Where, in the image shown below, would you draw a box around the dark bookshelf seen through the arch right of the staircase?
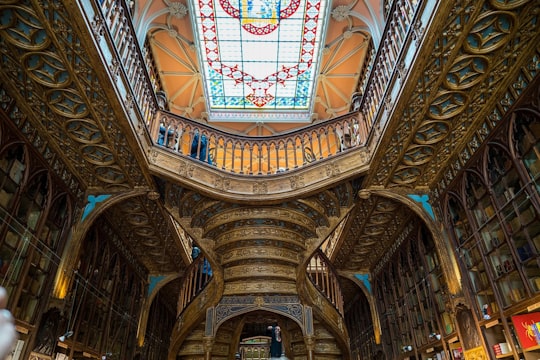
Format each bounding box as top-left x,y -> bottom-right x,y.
374,225 -> 450,359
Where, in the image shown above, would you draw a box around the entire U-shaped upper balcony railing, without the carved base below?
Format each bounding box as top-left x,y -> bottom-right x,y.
88,0 -> 433,175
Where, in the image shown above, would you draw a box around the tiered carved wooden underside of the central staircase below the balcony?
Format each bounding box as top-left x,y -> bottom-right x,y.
163,183 -> 358,295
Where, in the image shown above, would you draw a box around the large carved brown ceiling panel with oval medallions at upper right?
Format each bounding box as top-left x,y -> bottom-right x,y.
367,1 -> 539,189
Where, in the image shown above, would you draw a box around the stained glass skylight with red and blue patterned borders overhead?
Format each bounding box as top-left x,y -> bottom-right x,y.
192,0 -> 327,121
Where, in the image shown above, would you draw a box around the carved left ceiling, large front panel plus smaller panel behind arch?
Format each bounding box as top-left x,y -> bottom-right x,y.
0,2 -> 186,273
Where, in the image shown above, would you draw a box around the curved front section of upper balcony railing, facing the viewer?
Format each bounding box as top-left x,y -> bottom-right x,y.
152,111 -> 368,175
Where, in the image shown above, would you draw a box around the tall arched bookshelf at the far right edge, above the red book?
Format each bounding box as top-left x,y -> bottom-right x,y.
445,116 -> 540,359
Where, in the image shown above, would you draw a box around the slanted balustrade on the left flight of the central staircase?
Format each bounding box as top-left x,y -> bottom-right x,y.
177,255 -> 212,314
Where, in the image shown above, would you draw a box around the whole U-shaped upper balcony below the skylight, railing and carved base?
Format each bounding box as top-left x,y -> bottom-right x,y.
79,0 -> 435,200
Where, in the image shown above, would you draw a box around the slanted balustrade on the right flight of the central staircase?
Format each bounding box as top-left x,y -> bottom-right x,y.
307,250 -> 344,316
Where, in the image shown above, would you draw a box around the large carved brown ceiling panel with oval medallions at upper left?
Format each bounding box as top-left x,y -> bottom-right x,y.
0,1 -> 150,189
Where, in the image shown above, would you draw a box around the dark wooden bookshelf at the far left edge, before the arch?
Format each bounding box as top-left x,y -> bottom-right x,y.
0,144 -> 73,330
